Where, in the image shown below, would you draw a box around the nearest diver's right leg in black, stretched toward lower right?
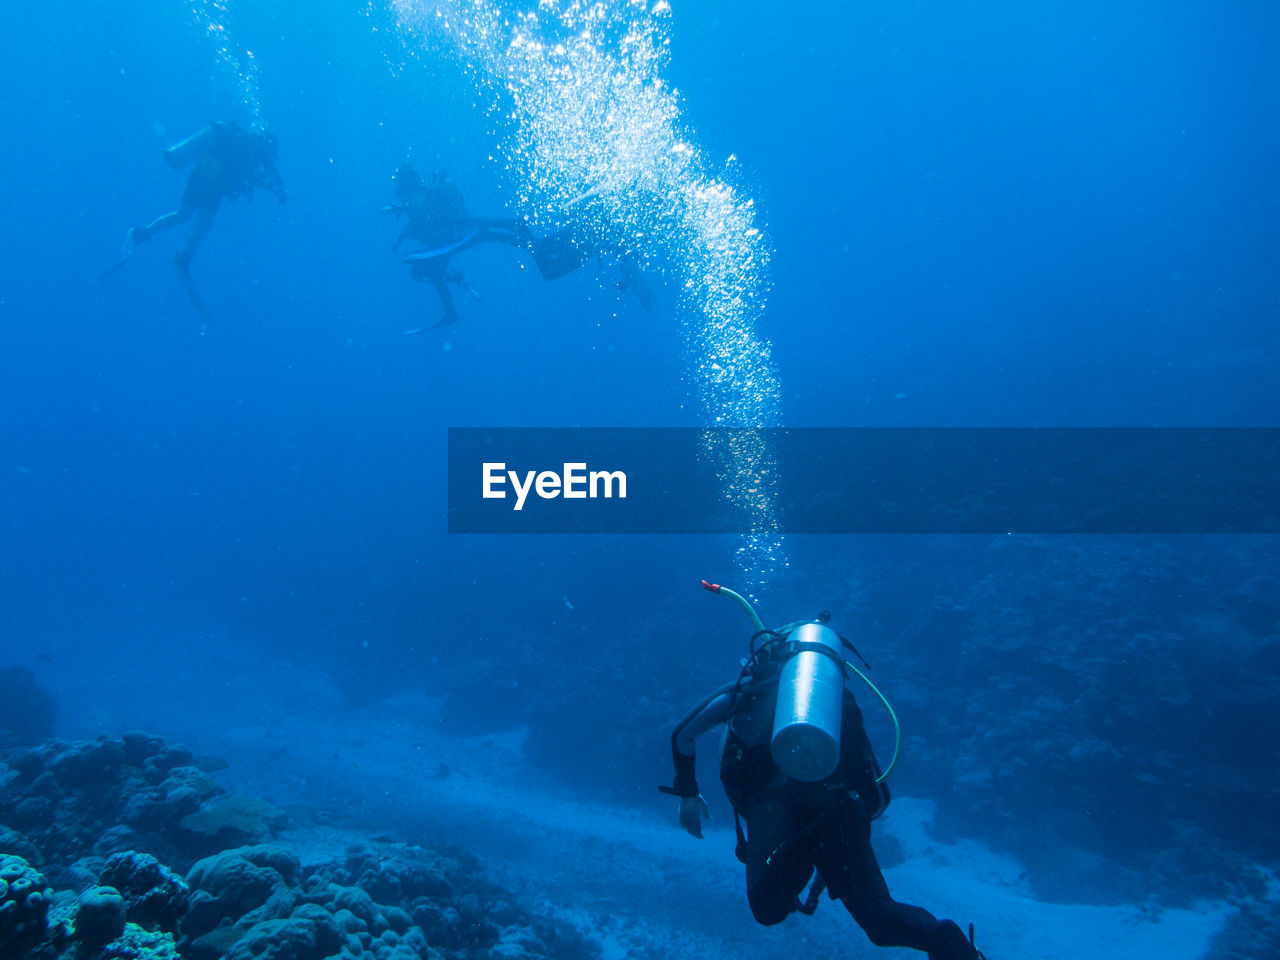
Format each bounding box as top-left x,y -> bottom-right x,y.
815,801 -> 978,960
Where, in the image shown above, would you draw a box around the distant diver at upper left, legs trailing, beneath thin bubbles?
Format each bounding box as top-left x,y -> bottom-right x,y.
99,120 -> 288,320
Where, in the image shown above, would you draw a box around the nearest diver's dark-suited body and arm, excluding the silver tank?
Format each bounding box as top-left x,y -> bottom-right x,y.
659,611 -> 983,960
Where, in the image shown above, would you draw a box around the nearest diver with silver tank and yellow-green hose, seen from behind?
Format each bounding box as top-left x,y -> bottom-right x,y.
659,580 -> 983,960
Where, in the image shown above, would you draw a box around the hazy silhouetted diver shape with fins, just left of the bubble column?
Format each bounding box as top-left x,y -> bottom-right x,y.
381,164 -> 616,334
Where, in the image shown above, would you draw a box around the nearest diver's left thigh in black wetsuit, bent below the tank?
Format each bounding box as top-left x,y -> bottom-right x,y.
745,794 -> 813,927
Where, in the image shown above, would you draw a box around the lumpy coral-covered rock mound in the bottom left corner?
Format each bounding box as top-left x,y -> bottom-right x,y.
0,733 -> 600,960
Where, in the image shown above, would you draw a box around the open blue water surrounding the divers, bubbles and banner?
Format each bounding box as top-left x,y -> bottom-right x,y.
0,0 -> 1280,957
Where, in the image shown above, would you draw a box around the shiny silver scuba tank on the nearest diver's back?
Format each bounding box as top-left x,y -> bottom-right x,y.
771,623 -> 845,782
